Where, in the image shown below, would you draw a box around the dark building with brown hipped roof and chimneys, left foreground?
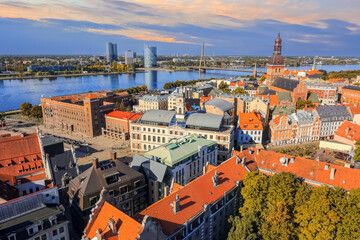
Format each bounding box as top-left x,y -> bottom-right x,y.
68,152 -> 147,229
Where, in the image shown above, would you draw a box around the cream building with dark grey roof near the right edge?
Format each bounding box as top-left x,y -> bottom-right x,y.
316,106 -> 352,139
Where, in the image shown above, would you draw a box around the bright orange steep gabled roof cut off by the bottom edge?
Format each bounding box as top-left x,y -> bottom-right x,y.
84,202 -> 143,240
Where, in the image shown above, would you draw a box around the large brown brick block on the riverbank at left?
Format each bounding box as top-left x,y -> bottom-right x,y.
41,91 -> 129,137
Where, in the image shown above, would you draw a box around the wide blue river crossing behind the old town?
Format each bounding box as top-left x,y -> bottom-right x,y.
0,65 -> 360,111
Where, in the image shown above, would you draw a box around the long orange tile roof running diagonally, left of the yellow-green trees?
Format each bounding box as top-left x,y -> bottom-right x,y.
134,152 -> 256,235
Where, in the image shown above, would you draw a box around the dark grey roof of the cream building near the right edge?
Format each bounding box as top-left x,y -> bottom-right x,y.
316,106 -> 352,122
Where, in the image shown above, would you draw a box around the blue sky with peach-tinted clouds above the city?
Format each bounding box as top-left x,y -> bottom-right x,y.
0,0 -> 360,56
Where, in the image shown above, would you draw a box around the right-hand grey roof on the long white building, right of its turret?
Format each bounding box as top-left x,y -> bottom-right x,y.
186,113 -> 223,130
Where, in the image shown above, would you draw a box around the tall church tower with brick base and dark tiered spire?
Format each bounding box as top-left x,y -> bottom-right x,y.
266,33 -> 285,88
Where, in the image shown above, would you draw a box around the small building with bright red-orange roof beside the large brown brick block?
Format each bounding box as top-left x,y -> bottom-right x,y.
102,110 -> 142,140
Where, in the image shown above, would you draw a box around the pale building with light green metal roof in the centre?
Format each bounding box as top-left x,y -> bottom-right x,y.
144,134 -> 218,186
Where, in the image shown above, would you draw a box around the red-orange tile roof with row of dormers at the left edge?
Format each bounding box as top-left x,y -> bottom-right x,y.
0,133 -> 44,180
